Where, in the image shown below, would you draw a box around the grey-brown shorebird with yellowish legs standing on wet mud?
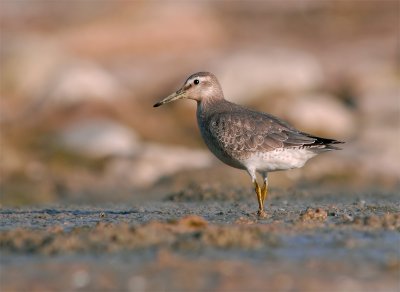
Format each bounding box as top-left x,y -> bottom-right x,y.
154,72 -> 343,218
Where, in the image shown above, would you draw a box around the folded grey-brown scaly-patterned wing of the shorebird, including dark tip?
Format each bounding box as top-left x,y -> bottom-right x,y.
210,111 -> 338,152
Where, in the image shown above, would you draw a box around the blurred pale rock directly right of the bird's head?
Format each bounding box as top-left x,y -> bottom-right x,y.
213,49 -> 323,103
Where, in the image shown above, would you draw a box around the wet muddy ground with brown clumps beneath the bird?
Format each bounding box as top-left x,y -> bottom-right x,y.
0,186 -> 400,291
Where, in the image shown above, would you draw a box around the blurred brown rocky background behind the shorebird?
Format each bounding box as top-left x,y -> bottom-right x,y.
0,0 -> 400,206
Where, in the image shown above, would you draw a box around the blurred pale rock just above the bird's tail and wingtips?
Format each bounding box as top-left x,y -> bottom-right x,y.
272,94 -> 357,139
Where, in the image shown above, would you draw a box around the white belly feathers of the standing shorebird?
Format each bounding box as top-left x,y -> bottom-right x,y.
243,148 -> 317,172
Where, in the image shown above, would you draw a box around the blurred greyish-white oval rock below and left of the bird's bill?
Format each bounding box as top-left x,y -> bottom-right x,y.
59,119 -> 139,158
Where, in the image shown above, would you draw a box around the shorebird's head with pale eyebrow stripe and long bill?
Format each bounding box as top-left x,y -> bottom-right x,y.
154,72 -> 224,107
